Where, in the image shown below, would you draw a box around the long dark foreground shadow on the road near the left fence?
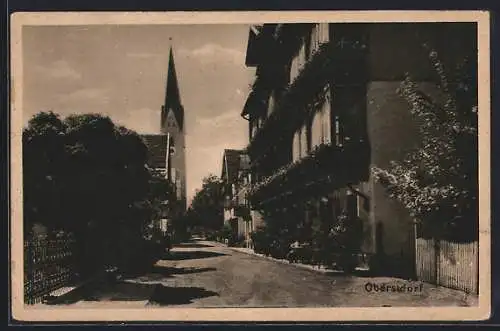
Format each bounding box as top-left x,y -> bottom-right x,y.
83,281 -> 218,306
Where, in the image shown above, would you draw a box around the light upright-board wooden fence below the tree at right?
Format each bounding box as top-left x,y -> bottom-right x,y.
416,238 -> 479,294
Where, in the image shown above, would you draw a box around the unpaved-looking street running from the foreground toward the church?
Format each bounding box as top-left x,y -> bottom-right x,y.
72,241 -> 474,307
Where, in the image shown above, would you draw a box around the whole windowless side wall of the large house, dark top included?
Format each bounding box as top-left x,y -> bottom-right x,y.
358,24 -> 466,276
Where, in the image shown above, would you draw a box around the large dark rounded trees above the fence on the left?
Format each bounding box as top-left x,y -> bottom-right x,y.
23,112 -> 172,274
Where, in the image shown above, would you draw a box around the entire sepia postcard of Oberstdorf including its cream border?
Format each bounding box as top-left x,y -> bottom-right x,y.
10,11 -> 491,321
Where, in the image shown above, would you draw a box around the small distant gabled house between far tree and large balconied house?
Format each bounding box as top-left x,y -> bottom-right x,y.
221,149 -> 251,245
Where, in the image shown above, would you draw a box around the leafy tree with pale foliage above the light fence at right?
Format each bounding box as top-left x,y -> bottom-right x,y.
373,46 -> 478,240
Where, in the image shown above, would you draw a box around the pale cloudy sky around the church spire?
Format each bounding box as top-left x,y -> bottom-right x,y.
23,25 -> 254,202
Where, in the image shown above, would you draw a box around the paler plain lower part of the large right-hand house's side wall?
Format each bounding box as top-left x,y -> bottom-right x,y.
359,81 -> 442,276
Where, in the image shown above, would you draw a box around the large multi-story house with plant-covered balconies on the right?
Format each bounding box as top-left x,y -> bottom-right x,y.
242,23 -> 476,276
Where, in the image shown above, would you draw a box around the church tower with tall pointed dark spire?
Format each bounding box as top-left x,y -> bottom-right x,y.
161,47 -> 186,213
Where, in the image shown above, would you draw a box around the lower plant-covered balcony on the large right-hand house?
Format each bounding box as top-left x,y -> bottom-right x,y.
249,142 -> 370,206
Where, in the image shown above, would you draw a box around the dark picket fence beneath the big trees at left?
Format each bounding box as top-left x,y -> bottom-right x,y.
24,238 -> 75,304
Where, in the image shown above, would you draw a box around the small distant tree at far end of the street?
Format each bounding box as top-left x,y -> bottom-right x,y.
187,174 -> 224,230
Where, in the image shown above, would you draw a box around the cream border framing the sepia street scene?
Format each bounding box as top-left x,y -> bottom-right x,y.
10,11 -> 491,322
